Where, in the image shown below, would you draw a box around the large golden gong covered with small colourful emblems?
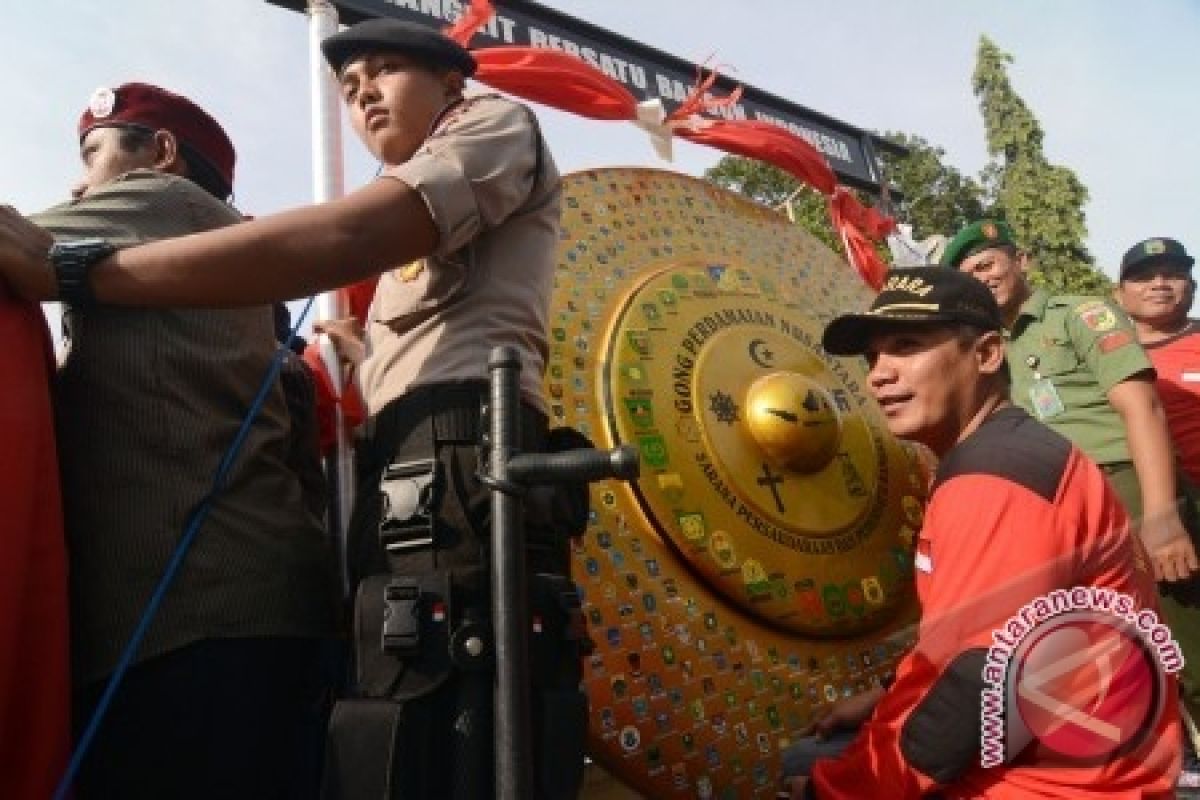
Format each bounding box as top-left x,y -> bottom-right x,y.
546,169 -> 925,798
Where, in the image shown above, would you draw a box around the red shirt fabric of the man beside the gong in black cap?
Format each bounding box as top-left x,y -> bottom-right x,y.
812,439 -> 1181,800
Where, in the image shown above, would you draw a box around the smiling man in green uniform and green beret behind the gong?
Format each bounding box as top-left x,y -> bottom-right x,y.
942,219 -> 1200,715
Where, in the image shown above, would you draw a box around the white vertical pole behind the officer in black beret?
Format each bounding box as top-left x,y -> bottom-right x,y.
308,0 -> 354,591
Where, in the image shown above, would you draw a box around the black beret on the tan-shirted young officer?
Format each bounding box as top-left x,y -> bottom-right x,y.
320,17 -> 476,78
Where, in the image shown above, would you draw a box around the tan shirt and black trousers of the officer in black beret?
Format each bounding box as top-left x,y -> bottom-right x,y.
332,95 -> 587,798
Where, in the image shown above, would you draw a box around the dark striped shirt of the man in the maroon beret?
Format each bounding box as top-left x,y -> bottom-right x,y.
34,170 -> 336,685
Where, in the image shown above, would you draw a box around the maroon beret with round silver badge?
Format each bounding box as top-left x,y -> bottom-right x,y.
79,83 -> 235,188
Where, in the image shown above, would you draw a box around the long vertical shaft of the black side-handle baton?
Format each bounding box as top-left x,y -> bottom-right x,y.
487,347 -> 533,800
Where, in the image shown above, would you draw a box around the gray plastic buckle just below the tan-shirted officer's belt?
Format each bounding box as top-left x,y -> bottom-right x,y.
379,458 -> 445,555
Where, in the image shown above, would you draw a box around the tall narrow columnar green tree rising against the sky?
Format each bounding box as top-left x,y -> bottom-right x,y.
971,36 -> 1109,293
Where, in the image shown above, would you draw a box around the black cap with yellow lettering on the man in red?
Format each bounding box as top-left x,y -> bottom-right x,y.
821,266 -> 1004,355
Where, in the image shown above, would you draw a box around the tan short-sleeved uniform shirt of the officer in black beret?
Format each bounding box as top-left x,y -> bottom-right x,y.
360,95 -> 560,414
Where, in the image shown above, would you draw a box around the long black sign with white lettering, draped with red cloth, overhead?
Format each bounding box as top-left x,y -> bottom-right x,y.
268,0 -> 904,194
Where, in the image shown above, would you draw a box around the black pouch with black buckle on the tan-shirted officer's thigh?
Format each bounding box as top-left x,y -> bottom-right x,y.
354,571 -> 455,700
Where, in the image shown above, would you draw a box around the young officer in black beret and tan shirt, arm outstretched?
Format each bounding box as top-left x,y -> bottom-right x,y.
0,19 -> 586,798
